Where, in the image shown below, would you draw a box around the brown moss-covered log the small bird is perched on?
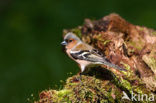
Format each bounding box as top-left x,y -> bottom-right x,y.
35,14 -> 156,103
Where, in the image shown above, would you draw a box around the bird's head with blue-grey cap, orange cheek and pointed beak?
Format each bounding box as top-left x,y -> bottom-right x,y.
61,32 -> 81,49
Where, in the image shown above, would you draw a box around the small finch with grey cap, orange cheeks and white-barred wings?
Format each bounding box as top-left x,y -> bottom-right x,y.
61,32 -> 126,73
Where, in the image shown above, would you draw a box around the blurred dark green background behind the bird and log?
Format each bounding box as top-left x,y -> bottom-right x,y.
0,0 -> 156,103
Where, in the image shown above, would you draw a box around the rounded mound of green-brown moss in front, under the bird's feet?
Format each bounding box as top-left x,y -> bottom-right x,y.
36,75 -> 127,103
